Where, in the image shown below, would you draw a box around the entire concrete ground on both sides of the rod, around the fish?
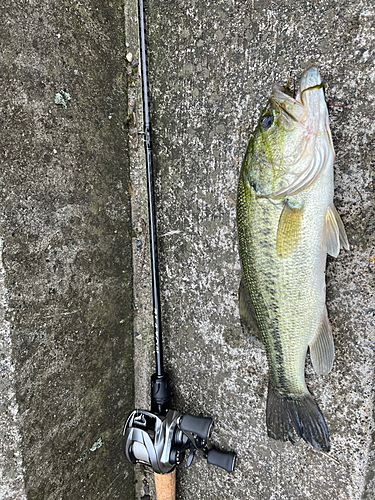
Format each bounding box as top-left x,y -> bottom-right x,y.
0,0 -> 375,500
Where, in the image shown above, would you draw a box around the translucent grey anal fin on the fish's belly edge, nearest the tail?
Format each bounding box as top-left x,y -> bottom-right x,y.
309,308 -> 335,375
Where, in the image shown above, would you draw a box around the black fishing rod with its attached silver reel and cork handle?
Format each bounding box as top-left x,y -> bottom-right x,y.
123,0 -> 235,500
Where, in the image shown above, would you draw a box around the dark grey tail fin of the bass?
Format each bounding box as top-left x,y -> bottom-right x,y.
267,384 -> 330,452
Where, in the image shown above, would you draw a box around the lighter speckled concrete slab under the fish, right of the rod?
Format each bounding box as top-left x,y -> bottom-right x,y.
129,0 -> 375,500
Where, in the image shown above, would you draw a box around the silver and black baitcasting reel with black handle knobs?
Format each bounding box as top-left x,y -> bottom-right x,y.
123,410 -> 235,474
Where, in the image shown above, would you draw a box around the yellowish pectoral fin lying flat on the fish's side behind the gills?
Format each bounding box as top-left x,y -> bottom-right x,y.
276,199 -> 303,257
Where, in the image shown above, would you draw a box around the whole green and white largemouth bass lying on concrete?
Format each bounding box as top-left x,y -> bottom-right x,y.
236,67 -> 349,452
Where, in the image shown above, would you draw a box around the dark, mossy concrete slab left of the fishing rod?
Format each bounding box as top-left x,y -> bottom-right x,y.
0,0 -> 134,500
